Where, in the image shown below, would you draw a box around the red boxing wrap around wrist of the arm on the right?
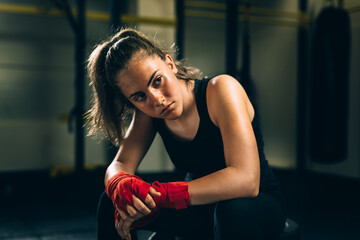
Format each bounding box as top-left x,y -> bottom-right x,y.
152,181 -> 190,209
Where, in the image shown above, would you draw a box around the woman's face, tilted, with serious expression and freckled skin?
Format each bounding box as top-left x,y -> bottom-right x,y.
117,54 -> 185,120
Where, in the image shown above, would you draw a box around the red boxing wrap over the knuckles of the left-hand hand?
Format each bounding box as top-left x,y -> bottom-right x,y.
105,172 -> 150,212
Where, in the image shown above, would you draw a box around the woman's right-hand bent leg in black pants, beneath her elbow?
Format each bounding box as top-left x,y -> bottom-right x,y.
214,193 -> 285,240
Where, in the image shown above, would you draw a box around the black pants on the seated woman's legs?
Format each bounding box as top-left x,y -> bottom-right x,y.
97,192 -> 286,240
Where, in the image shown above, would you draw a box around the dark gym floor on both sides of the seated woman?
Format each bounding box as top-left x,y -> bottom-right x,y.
0,169 -> 360,240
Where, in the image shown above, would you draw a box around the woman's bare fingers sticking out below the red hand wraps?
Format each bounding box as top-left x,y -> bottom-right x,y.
115,187 -> 161,240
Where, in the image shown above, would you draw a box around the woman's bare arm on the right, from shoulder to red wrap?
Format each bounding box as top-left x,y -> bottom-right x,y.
189,75 -> 260,205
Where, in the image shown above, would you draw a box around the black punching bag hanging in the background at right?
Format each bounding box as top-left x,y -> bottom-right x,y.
310,7 -> 350,163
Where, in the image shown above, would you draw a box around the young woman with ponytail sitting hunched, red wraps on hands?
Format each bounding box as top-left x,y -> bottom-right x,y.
88,29 -> 285,239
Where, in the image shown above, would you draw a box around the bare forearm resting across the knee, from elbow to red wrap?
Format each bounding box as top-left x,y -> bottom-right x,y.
189,167 -> 260,205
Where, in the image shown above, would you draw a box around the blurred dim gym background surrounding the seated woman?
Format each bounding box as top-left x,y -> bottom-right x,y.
0,0 -> 360,239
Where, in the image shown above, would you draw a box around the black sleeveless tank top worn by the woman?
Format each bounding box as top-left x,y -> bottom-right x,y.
154,79 -> 279,195
